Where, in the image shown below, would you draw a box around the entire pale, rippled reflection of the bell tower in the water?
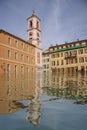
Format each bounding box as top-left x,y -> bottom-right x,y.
26,71 -> 42,125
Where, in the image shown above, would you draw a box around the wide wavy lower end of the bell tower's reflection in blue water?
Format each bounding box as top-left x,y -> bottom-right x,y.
26,99 -> 41,125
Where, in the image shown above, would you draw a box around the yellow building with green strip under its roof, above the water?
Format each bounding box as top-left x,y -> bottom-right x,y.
43,40 -> 87,73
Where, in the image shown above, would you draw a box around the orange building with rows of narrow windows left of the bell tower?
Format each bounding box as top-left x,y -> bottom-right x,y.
0,30 -> 35,80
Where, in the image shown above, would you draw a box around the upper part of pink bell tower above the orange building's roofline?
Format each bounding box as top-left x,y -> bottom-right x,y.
27,11 -> 41,48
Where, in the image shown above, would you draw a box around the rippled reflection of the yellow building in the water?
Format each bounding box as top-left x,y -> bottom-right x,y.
43,72 -> 87,104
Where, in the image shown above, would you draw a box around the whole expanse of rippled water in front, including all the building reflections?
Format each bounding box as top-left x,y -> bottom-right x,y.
0,73 -> 87,130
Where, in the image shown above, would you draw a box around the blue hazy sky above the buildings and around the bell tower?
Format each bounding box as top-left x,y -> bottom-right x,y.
0,0 -> 87,50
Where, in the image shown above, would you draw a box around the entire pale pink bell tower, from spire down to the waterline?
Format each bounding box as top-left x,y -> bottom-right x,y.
27,11 -> 42,69
